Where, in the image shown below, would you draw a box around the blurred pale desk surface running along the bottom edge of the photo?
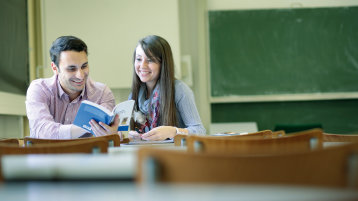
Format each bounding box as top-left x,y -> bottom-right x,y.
0,181 -> 358,201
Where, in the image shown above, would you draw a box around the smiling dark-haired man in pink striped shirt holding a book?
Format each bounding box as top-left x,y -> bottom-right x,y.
26,36 -> 119,139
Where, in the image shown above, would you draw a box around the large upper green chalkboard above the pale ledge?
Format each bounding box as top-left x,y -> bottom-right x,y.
209,7 -> 358,97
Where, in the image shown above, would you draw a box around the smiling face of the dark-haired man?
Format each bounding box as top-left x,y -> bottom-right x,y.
51,51 -> 89,99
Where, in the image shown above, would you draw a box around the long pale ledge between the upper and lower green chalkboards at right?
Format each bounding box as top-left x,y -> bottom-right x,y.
210,92 -> 358,103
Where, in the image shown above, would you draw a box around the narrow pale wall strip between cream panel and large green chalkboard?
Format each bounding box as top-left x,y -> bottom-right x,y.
179,0 -> 211,133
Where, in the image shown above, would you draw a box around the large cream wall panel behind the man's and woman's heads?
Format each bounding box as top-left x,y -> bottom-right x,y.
42,0 -> 180,89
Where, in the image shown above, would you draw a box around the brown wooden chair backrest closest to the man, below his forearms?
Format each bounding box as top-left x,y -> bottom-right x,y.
24,134 -> 121,147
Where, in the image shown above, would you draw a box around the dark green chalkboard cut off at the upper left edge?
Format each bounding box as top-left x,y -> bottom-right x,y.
0,0 -> 29,95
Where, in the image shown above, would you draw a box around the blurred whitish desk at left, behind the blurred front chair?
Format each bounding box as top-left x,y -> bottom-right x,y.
1,143 -> 183,181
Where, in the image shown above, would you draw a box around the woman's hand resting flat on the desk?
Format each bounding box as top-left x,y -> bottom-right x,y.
142,126 -> 177,140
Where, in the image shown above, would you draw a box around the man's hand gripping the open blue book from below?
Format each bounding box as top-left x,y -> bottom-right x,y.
89,115 -> 119,137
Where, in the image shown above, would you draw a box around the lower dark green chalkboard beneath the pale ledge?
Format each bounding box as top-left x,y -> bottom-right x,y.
211,99 -> 358,134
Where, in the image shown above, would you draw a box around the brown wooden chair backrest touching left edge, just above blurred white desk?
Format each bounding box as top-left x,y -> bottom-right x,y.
0,140 -> 108,155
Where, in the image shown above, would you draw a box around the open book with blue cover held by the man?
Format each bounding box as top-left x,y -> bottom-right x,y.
73,100 -> 134,134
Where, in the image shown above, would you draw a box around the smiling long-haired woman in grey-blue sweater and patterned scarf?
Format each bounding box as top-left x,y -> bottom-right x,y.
129,35 -> 206,140
